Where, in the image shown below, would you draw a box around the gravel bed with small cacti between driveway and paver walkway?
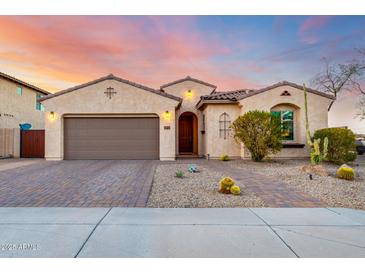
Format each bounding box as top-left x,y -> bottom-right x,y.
147,163 -> 265,208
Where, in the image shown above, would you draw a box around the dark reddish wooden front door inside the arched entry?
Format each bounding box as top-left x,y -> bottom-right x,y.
179,115 -> 194,153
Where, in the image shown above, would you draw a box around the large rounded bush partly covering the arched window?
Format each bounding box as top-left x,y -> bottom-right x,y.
232,110 -> 282,162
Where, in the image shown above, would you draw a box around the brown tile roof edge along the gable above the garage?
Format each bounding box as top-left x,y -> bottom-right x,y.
39,74 -> 182,102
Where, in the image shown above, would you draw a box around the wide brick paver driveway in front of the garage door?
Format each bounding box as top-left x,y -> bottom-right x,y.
0,160 -> 158,207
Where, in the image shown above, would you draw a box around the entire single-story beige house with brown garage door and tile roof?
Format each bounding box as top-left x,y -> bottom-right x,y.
40,75 -> 334,160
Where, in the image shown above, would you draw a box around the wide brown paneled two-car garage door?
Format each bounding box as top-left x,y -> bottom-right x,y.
64,117 -> 159,159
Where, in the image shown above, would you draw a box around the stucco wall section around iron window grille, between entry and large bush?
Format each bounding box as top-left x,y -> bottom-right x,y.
204,104 -> 241,158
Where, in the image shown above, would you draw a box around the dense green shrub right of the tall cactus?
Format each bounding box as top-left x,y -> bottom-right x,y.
313,128 -> 357,164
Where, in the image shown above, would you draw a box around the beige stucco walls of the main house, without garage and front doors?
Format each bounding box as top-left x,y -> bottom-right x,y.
42,76 -> 332,160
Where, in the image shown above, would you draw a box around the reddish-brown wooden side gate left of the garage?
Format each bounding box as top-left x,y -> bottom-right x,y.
20,129 -> 44,158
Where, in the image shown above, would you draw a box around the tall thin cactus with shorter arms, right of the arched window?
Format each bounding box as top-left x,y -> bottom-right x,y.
303,84 -> 328,165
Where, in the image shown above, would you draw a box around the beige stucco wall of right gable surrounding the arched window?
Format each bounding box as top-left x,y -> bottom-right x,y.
240,86 -> 331,158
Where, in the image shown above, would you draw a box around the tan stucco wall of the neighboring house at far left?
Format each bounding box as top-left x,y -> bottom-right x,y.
0,77 -> 44,129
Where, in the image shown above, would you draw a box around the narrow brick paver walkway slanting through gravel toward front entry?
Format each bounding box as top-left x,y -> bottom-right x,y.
205,160 -> 326,207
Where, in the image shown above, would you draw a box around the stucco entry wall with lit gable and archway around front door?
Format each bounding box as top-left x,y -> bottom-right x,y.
164,80 -> 214,156
